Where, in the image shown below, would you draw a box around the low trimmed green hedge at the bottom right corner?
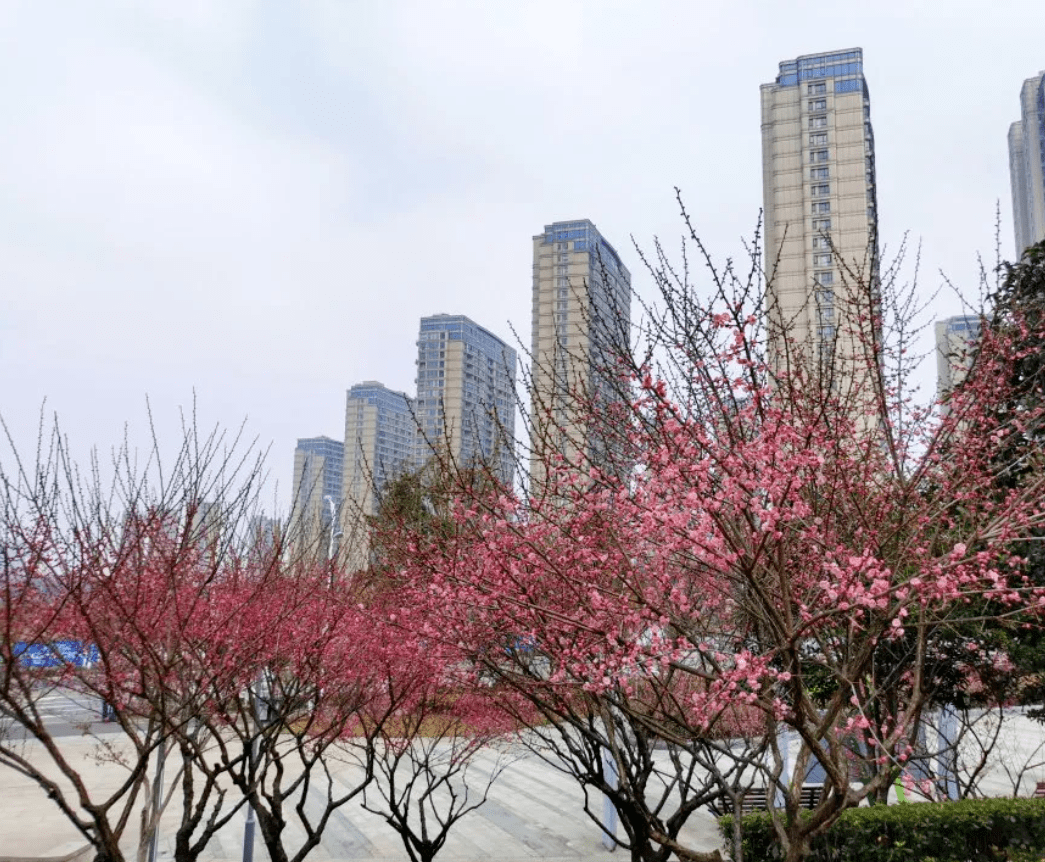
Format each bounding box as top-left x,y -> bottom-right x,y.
719,799 -> 1045,862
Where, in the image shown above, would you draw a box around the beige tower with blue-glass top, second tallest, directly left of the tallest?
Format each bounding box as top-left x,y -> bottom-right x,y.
530,219 -> 631,488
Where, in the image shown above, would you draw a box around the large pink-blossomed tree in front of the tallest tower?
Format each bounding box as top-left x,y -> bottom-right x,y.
386,201 -> 1043,860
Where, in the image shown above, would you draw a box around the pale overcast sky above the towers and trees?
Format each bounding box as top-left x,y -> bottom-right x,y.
0,0 -> 1045,507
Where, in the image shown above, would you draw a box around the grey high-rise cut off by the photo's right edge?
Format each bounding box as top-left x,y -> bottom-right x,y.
1008,72 -> 1045,259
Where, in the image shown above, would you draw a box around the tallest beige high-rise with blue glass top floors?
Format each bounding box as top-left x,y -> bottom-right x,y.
761,48 -> 878,368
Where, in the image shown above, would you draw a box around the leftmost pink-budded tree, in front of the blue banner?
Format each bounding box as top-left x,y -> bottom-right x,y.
0,413 -> 271,860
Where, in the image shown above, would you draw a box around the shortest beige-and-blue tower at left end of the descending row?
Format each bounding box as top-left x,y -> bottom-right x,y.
288,437 -> 345,558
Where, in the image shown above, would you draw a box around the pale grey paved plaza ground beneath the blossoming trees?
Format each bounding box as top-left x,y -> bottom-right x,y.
6,712 -> 1045,862
